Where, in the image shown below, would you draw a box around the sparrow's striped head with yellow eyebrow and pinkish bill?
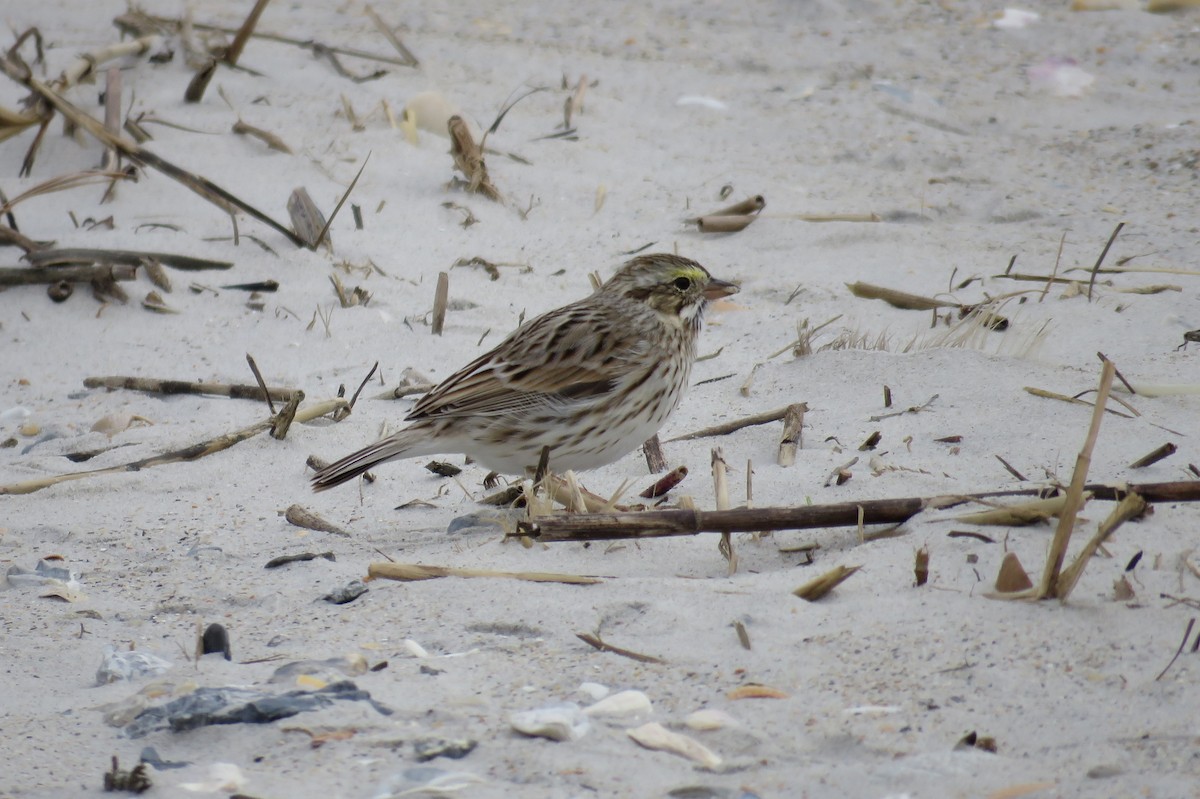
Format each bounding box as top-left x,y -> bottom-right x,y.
600,253 -> 738,324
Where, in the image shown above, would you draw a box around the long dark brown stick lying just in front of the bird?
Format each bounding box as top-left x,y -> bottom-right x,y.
512,480 -> 1200,542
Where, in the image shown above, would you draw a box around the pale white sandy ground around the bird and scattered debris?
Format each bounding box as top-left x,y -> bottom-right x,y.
0,0 -> 1200,799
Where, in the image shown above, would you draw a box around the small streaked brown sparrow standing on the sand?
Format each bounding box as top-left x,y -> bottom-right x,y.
312,254 -> 738,491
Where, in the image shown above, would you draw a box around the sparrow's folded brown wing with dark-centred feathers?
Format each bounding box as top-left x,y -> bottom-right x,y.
408,304 -> 646,420
